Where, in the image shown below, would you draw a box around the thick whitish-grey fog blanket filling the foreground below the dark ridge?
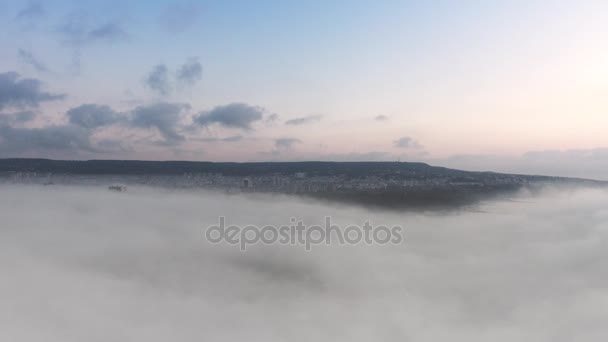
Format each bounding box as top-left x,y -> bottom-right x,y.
0,186 -> 608,342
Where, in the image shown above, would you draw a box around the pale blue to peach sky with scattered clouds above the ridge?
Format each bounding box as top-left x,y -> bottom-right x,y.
0,0 -> 608,179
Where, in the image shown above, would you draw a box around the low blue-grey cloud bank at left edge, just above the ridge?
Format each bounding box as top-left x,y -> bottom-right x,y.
0,125 -> 100,155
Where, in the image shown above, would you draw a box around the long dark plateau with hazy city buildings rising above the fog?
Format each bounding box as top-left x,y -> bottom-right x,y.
0,159 -> 608,209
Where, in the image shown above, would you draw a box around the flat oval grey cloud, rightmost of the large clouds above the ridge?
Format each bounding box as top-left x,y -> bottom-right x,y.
194,103 -> 265,130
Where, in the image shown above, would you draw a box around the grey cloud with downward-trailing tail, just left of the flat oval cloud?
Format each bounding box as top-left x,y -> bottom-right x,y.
130,102 -> 190,144
